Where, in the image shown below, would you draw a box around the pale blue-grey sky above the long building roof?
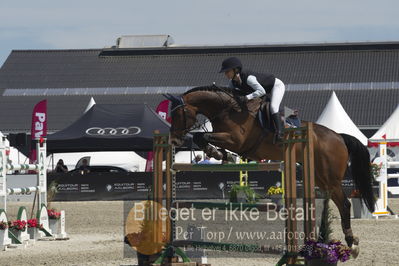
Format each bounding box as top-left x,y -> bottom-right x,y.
0,0 -> 399,66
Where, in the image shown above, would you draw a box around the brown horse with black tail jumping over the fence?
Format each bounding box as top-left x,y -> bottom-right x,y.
165,86 -> 375,254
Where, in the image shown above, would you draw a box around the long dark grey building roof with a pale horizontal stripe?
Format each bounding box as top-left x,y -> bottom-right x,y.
0,42 -> 399,131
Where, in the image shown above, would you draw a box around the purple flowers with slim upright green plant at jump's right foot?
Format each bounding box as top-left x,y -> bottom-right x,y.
299,199 -> 352,266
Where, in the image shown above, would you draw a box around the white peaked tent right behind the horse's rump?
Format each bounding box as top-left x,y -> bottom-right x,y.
316,91 -> 367,145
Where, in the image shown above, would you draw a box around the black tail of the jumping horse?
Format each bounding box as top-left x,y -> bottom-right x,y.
340,134 -> 375,212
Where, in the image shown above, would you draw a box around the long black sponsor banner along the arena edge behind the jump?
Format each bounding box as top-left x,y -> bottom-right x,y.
48,172 -> 353,201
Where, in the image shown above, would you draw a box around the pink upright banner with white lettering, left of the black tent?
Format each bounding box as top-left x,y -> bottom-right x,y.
29,100 -> 47,163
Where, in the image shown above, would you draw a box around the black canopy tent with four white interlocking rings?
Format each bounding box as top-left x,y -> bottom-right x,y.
47,104 -> 173,153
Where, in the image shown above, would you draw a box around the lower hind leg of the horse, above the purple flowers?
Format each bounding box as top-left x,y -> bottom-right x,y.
331,184 -> 359,257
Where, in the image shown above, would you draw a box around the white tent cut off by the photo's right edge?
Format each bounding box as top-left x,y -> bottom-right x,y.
370,105 -> 399,142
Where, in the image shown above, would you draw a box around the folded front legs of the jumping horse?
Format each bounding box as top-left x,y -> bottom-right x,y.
193,132 -> 239,160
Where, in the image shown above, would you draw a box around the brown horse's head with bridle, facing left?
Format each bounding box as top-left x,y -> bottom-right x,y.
164,93 -> 197,147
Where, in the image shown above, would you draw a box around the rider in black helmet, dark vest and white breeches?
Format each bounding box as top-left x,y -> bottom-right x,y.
219,57 -> 285,141
